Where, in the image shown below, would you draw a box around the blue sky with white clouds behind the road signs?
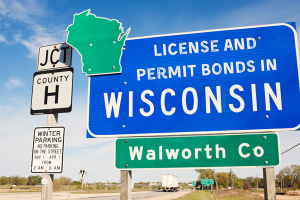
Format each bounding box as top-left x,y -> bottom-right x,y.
0,0 -> 300,182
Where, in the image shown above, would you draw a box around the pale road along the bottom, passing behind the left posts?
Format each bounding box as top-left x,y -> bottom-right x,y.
0,190 -> 190,200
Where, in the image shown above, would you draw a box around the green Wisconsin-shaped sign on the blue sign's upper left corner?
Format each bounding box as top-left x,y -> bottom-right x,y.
67,9 -> 130,76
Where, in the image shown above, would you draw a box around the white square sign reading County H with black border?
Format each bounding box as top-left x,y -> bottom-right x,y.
30,67 -> 73,115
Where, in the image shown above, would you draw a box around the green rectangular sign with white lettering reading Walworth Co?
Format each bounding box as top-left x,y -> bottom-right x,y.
115,133 -> 280,170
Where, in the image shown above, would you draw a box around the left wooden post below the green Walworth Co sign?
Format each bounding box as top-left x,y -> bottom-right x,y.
120,170 -> 132,200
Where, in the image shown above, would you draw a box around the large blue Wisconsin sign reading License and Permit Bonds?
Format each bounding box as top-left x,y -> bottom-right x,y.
87,23 -> 300,137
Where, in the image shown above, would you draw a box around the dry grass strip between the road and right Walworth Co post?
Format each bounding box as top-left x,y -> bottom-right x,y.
177,190 -> 263,200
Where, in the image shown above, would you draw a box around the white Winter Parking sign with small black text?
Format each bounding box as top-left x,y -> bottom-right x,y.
31,126 -> 65,174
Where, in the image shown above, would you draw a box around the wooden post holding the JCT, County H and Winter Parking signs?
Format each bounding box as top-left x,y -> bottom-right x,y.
42,113 -> 58,200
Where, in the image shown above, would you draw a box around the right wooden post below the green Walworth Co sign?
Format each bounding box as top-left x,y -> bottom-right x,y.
263,167 -> 276,200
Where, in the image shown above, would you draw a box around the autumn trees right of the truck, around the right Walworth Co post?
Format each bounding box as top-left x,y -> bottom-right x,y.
196,164 -> 300,190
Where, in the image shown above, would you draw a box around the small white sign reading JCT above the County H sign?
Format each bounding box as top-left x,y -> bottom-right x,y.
37,43 -> 72,71
